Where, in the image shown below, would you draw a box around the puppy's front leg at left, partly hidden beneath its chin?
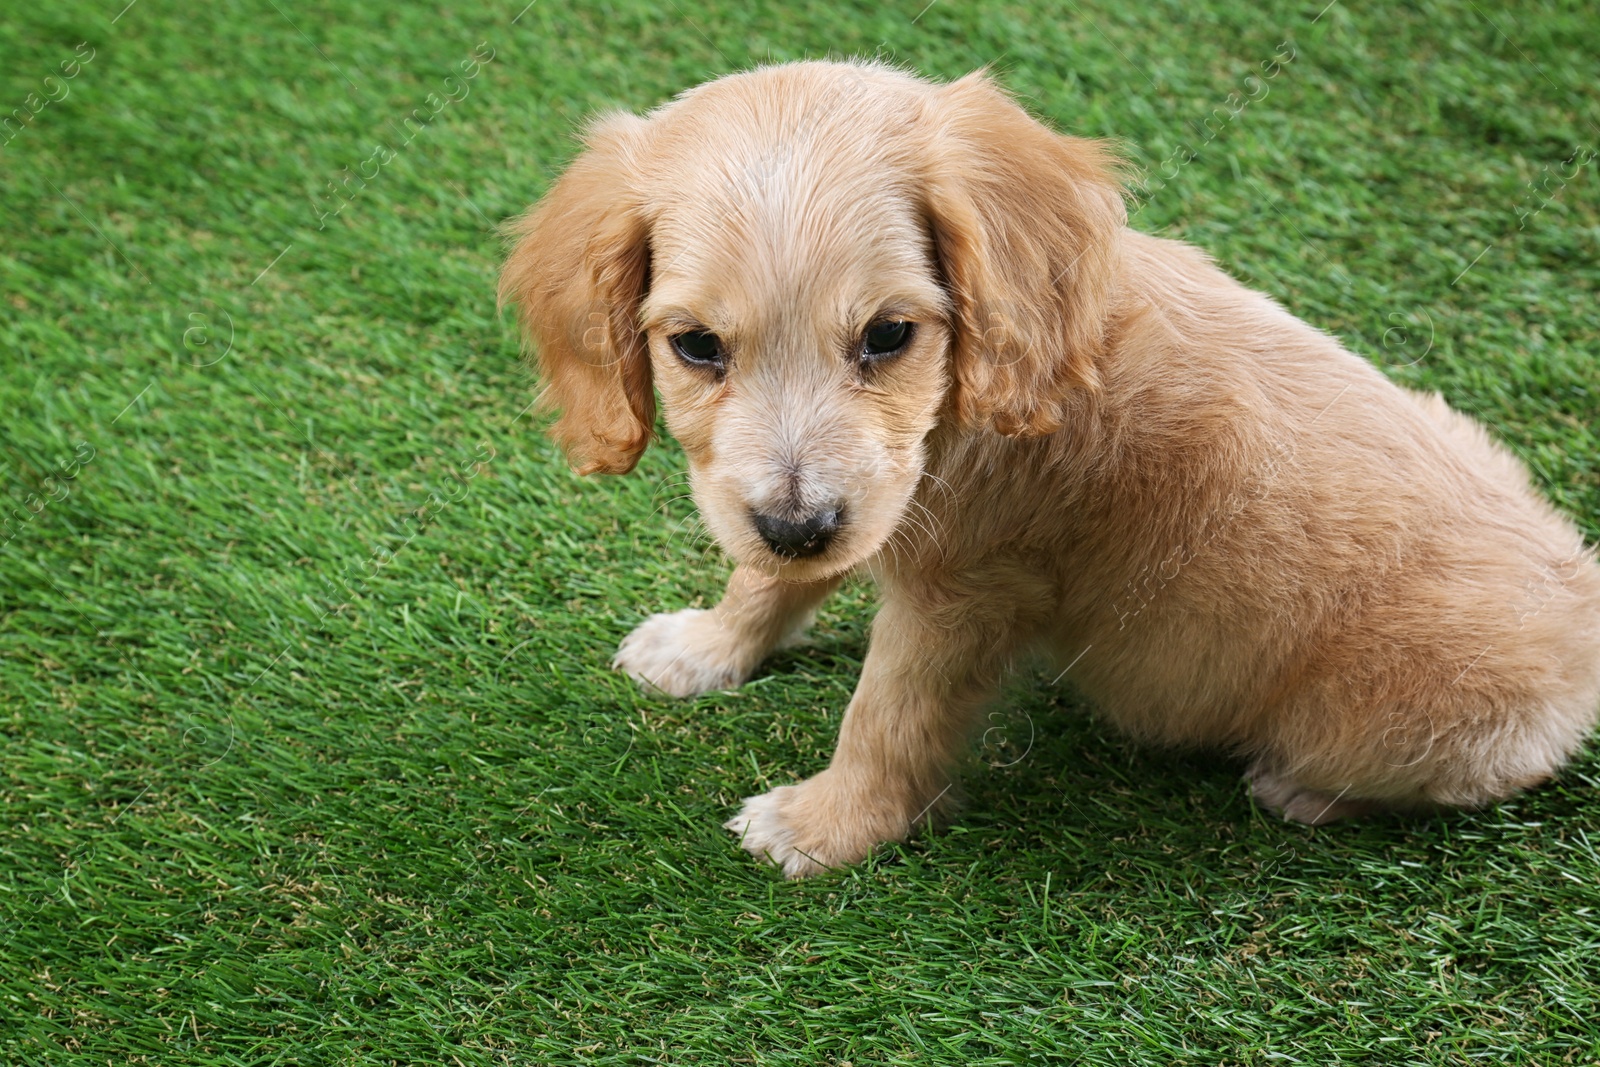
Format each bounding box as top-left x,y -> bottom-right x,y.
611,565 -> 842,696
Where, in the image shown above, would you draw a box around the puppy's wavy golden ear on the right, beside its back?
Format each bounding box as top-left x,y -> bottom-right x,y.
925,72 -> 1128,437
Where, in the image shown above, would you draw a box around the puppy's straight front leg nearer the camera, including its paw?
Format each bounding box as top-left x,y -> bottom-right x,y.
725,597 -> 1014,878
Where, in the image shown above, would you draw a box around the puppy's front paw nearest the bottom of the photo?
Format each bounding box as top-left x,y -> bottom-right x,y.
723,771 -> 942,878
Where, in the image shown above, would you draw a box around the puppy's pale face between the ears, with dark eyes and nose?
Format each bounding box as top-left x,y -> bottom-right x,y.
642,105 -> 950,579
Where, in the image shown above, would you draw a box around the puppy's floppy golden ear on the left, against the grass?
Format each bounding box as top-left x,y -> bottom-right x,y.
499,114 -> 656,474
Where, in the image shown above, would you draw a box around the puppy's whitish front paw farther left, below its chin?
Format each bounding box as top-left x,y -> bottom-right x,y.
611,608 -> 754,696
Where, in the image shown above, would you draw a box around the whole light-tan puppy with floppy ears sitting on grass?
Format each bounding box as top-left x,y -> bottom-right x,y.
499,62 -> 1600,877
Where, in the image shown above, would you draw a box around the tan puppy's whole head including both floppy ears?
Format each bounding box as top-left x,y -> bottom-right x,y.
501,62 -> 1125,581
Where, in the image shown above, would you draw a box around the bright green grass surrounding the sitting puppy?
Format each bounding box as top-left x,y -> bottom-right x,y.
0,0 -> 1600,1067
